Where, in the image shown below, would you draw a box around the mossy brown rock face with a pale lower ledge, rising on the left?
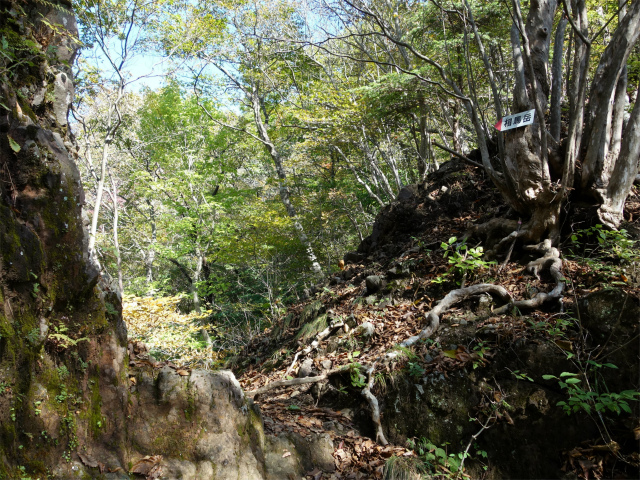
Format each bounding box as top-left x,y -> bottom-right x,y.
0,0 -> 330,480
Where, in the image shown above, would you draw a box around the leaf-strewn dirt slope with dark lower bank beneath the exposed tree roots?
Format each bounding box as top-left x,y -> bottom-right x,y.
231,161 -> 640,478
